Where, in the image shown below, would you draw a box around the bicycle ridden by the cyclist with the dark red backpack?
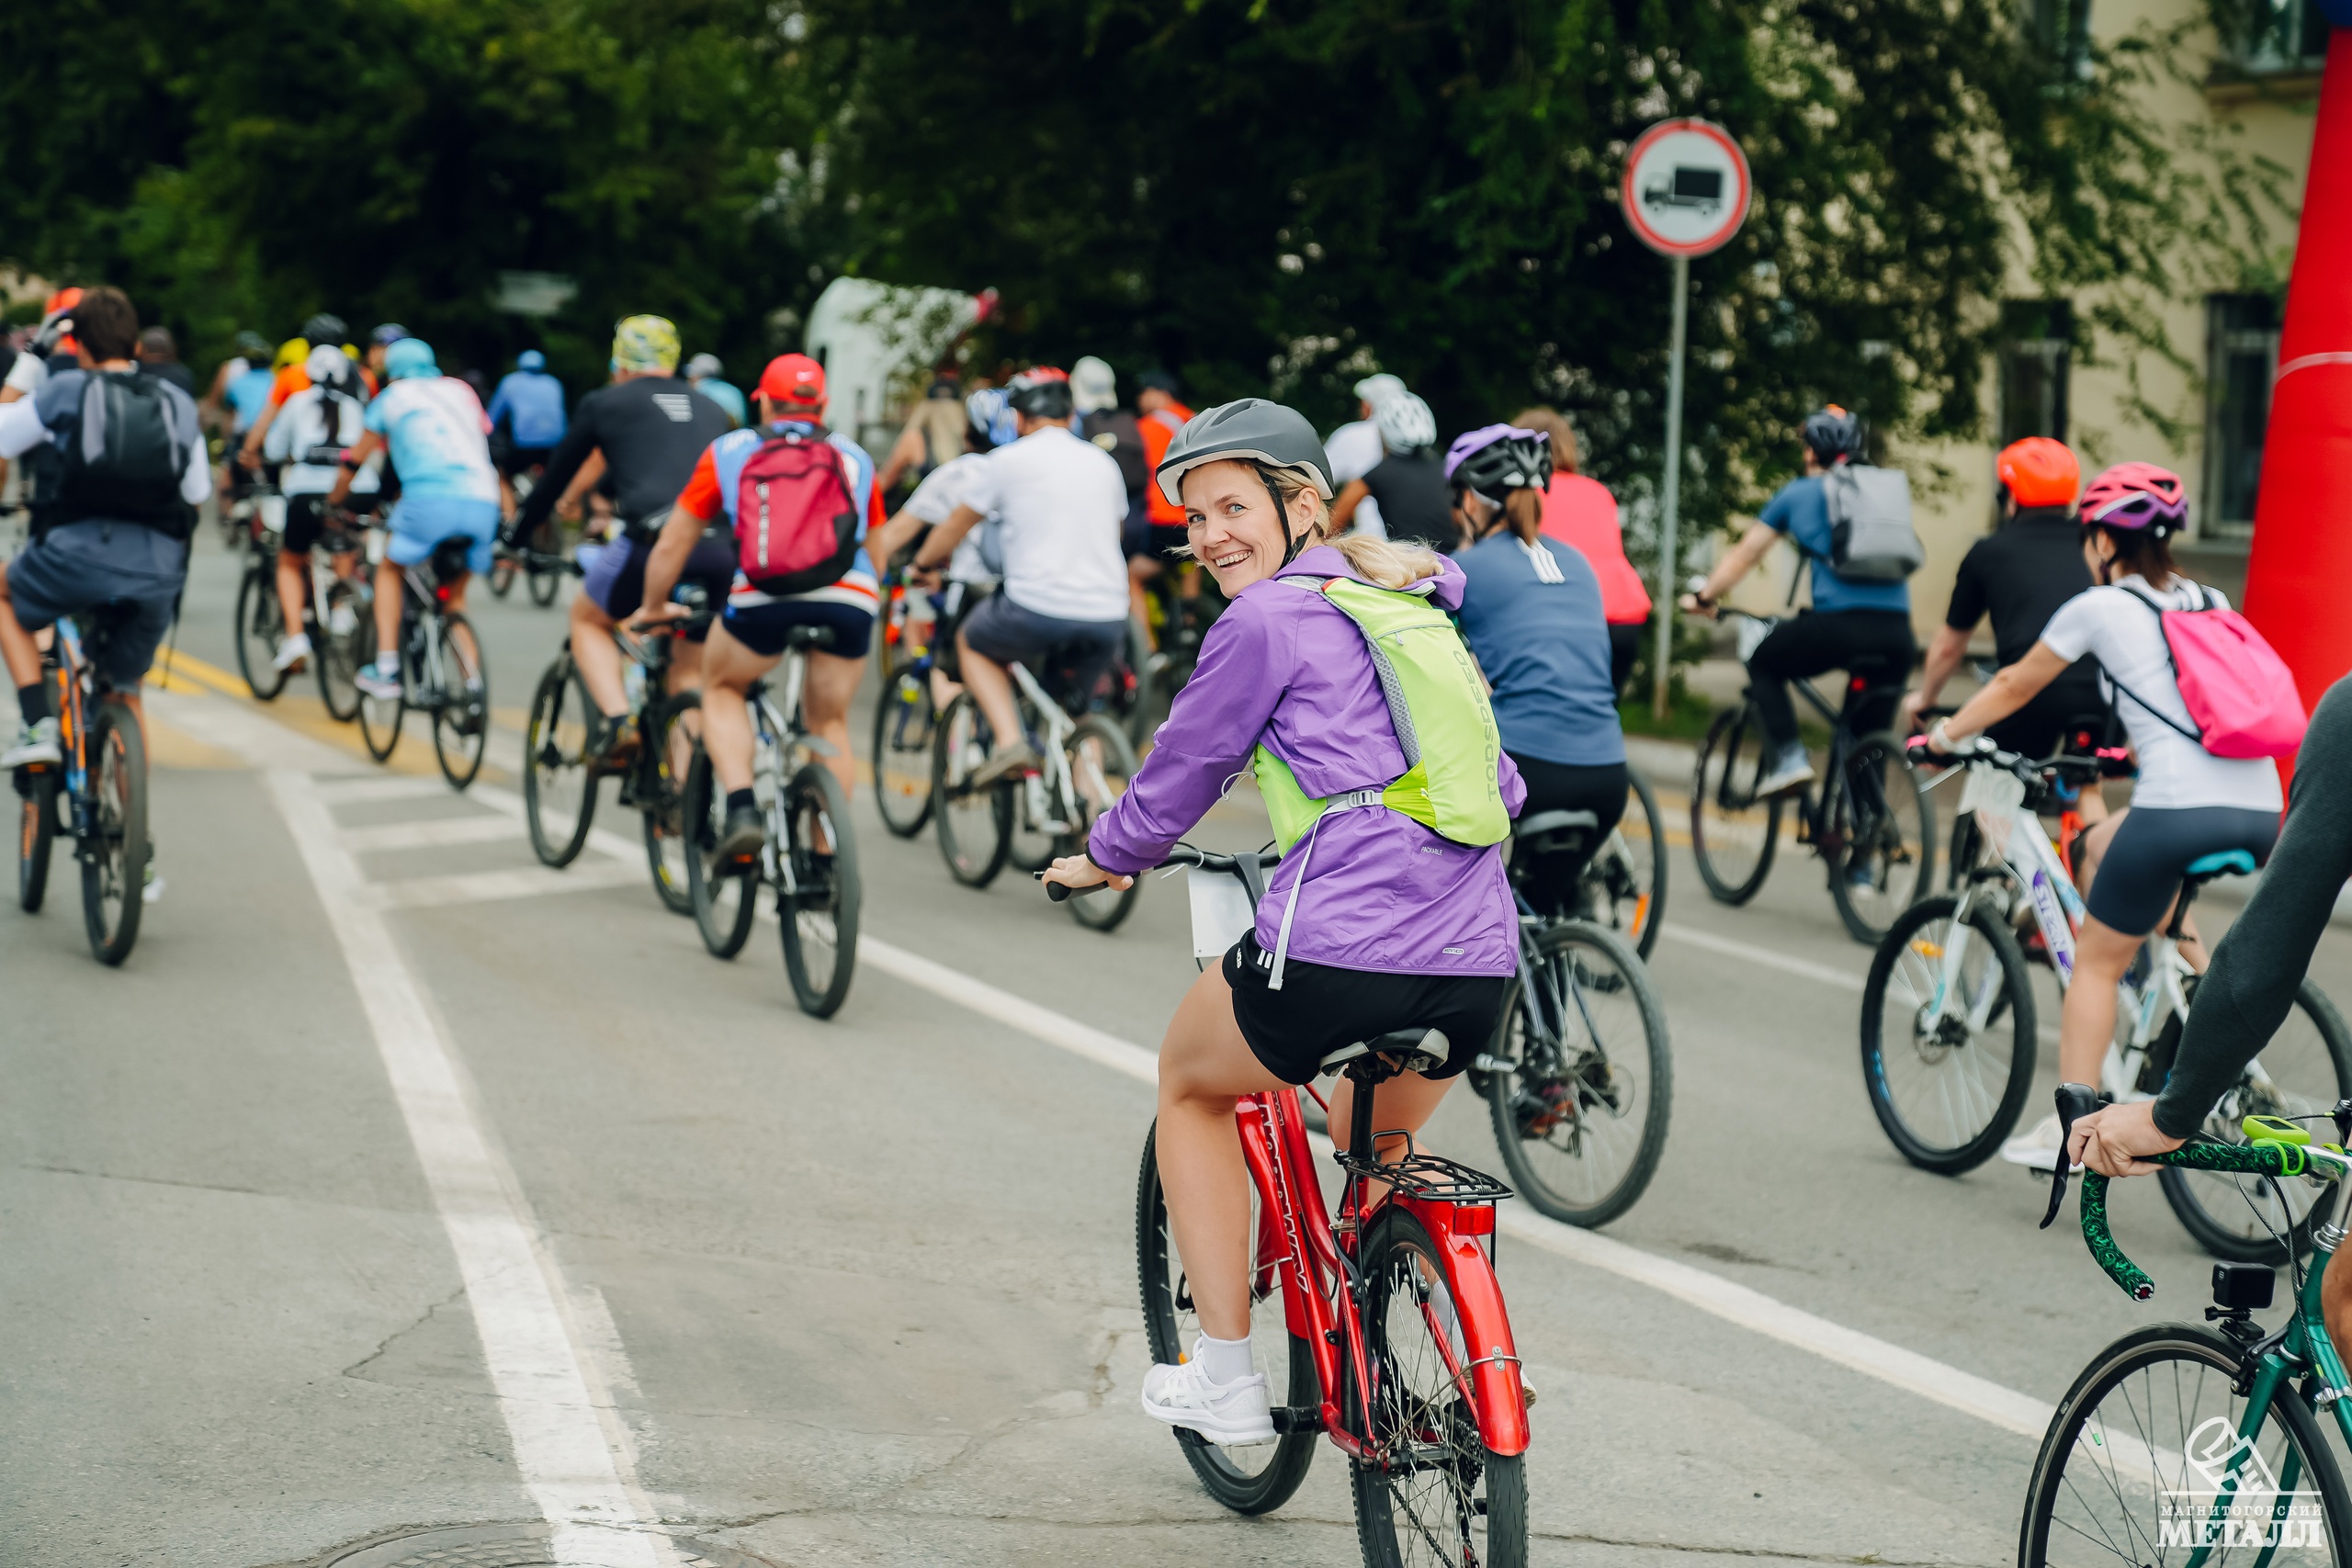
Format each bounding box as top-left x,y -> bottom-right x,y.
680,626 -> 864,1018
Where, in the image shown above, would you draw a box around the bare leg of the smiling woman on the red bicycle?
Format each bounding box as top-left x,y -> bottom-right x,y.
1158,964 -> 1284,1340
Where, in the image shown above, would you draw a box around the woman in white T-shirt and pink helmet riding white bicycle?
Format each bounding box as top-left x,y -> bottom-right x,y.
1928,463 -> 2286,1170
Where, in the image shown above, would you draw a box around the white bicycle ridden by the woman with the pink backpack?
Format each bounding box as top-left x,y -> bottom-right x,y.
1863,739 -> 2352,1262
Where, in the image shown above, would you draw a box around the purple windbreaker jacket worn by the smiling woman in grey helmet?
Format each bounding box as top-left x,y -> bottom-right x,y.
1087,546 -> 1526,976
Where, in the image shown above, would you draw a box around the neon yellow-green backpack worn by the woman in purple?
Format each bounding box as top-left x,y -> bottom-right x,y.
1249,576 -> 1510,989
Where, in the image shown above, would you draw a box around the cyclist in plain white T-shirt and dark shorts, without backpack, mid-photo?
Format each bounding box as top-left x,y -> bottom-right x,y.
915,367 -> 1126,785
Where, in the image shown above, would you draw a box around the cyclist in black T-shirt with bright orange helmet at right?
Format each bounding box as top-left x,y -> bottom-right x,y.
1903,434 -> 2108,823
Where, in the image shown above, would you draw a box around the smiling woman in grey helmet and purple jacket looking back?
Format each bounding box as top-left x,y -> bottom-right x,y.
1046,398 -> 1524,1443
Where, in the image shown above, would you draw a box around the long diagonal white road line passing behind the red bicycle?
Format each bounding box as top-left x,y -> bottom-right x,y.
858,926 -> 2051,1438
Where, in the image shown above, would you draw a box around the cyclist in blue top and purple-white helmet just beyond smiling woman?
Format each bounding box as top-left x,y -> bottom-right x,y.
1446,425 -> 1625,917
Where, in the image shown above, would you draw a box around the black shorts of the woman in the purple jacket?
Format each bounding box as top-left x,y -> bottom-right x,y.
1223,931 -> 1510,1084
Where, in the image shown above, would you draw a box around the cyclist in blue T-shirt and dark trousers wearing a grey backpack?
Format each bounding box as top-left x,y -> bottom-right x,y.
1681,404 -> 1917,795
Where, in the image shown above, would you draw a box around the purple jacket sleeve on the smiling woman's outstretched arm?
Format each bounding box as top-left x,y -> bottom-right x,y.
1087,585 -> 1298,877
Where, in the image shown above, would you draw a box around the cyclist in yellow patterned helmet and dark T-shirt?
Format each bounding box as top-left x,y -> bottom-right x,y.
505,315 -> 736,766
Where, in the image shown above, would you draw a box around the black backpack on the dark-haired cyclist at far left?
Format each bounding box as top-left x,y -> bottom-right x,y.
51,371 -> 198,538
